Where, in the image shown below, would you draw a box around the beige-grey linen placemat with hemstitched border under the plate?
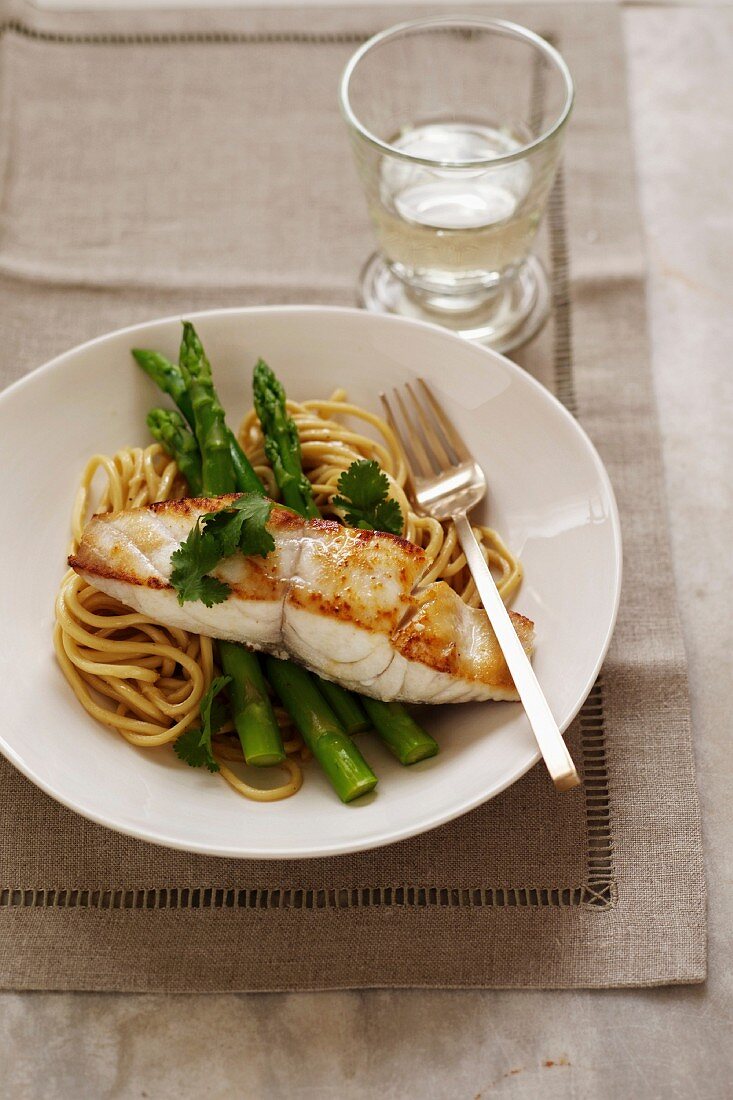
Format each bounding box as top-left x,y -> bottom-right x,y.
0,3 -> 705,991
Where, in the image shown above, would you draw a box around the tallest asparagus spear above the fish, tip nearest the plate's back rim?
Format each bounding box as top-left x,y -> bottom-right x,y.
179,321 -> 237,496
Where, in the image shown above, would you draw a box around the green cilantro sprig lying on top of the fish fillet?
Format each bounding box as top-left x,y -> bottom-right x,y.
171,493 -> 275,607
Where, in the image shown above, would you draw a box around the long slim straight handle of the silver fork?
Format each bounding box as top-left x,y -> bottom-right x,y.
451,512 -> 580,791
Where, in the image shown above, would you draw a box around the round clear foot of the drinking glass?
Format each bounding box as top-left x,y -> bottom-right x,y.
359,252 -> 550,352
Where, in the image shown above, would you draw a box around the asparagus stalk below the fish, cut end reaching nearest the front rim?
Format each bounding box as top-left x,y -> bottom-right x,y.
266,657 -> 376,802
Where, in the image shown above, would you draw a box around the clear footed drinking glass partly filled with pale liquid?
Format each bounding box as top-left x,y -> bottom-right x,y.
339,17 -> 573,351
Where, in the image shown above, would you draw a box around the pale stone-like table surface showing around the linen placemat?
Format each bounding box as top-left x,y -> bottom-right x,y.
0,0 -> 733,1100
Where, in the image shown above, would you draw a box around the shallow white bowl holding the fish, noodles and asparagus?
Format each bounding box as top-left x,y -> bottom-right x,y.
0,306 -> 621,859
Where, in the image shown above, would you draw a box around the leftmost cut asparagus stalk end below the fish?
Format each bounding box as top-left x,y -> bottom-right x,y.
219,641 -> 285,767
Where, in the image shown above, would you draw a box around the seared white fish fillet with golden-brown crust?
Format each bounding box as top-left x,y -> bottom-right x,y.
69,496 -> 534,703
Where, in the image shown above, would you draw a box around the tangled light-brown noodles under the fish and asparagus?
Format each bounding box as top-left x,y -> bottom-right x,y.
54,389 -> 522,802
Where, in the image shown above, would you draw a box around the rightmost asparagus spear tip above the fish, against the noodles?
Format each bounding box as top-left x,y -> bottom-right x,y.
252,360 -> 320,519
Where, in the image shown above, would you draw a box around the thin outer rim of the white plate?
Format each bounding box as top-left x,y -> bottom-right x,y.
0,304 -> 623,860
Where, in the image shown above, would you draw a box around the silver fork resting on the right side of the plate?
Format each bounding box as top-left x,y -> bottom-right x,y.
380,378 -> 580,791
